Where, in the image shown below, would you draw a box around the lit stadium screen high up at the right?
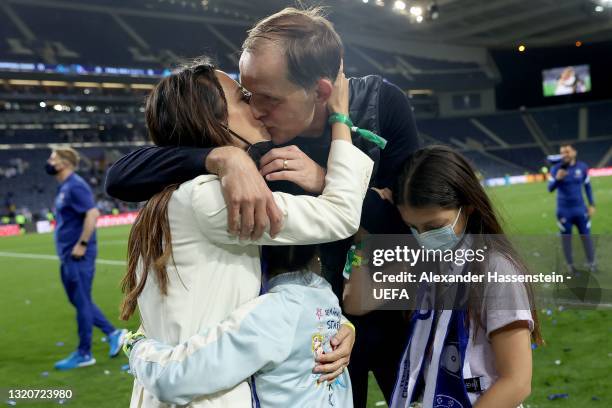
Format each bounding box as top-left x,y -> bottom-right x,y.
542,65 -> 591,96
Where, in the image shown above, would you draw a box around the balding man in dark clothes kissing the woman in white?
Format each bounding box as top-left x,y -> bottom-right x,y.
106,8 -> 420,407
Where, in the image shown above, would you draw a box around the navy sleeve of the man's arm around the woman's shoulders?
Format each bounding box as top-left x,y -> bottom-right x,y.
105,146 -> 212,202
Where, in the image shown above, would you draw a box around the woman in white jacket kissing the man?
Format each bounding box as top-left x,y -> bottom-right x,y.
122,63 -> 372,407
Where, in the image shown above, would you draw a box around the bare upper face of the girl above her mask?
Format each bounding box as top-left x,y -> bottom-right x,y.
398,205 -> 467,235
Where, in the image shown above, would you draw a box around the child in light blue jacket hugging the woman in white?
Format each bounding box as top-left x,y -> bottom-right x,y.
126,245 -> 353,408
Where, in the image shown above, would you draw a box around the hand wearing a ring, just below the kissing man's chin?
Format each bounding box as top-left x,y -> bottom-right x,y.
259,146 -> 325,194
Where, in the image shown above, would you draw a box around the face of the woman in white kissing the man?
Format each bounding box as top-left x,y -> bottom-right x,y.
215,71 -> 270,144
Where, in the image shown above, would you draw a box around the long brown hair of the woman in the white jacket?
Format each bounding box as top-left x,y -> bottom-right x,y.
120,60 -> 232,320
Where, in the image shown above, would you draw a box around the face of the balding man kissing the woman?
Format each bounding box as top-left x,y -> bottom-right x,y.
240,44 -> 316,144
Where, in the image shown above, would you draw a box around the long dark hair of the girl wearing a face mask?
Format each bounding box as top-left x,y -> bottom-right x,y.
393,145 -> 542,343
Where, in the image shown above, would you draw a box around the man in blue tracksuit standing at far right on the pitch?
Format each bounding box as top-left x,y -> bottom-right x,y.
548,144 -> 596,273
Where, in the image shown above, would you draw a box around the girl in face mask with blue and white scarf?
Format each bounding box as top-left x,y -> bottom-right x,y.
344,146 -> 542,408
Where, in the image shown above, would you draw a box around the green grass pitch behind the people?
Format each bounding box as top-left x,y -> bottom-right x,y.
0,177 -> 612,408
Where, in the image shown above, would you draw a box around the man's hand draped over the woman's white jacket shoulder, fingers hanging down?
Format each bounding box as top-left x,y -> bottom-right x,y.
206,146 -> 283,239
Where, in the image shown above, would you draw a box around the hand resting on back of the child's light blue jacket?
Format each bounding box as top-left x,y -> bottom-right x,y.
313,324 -> 355,383
